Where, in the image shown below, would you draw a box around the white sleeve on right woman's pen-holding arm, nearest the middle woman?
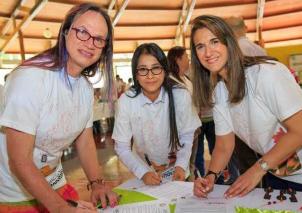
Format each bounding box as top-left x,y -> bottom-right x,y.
213,82 -> 233,135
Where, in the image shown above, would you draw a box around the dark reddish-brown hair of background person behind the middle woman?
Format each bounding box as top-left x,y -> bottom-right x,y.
167,46 -> 186,83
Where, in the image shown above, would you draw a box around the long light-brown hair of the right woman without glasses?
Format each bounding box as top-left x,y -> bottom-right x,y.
191,15 -> 275,108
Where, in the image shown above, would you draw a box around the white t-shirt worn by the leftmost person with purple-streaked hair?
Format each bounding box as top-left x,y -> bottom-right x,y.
0,67 -> 93,202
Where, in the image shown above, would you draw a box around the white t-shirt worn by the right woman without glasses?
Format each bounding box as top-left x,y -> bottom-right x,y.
214,62 -> 302,183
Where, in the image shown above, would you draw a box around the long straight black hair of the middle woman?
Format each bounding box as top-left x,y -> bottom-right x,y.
128,43 -> 183,152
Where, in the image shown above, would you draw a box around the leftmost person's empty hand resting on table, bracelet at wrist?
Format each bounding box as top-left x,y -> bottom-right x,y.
90,184 -> 118,209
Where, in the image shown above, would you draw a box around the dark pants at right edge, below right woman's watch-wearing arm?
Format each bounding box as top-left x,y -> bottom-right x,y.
263,173 -> 302,191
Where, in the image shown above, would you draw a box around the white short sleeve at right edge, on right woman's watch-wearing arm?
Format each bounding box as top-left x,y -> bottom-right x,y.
257,62 -> 302,121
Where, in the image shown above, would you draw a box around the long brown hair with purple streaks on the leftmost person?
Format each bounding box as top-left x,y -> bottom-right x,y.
20,3 -> 113,97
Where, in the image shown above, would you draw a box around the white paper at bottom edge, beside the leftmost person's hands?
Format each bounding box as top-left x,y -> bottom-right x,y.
99,201 -> 170,213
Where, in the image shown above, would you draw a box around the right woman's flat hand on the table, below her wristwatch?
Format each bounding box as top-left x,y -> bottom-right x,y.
225,162 -> 266,198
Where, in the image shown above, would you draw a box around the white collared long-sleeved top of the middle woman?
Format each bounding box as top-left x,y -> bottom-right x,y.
112,88 -> 201,178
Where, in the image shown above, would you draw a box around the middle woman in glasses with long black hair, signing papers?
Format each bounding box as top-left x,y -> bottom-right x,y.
112,43 -> 200,185
